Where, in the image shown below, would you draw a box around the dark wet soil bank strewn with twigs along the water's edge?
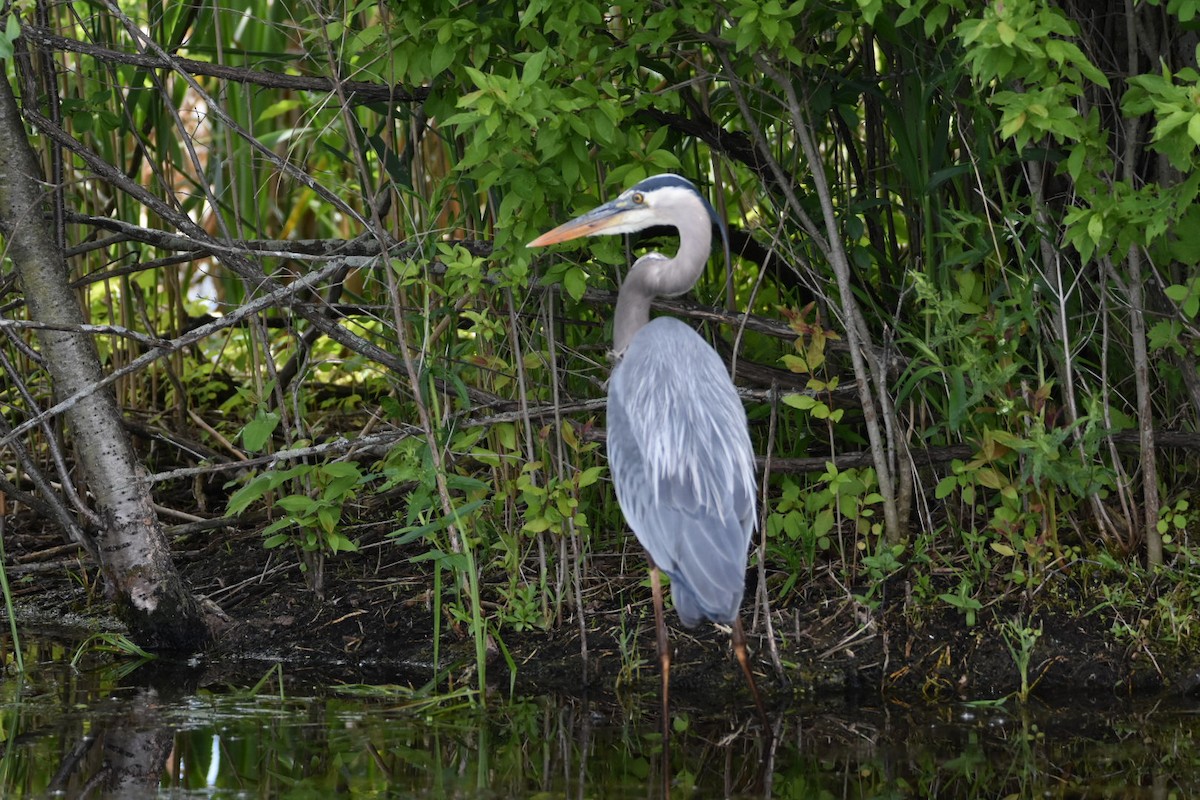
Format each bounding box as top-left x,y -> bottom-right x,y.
6,503 -> 1200,708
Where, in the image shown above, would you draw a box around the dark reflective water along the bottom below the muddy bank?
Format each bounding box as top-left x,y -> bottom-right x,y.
0,638 -> 1200,799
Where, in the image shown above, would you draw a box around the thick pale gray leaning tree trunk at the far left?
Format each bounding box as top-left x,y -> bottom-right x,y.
0,73 -> 209,650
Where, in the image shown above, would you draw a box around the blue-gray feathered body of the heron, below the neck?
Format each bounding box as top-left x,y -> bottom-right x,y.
607,317 -> 755,627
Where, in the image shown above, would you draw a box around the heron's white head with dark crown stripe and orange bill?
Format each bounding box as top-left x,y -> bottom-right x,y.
527,175 -> 724,247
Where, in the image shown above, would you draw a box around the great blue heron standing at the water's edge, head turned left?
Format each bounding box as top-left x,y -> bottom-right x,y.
529,175 -> 767,736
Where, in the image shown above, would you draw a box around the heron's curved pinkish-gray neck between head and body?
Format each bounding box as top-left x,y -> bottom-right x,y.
612,214 -> 713,356
